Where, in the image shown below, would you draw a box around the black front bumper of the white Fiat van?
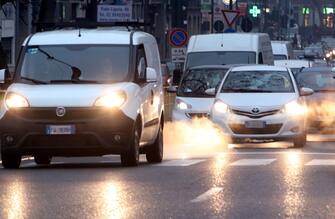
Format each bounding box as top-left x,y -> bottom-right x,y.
0,108 -> 135,156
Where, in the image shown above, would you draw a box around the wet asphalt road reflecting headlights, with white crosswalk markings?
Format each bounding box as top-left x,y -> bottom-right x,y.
0,135 -> 335,219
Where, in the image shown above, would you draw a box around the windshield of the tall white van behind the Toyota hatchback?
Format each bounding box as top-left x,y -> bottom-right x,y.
186,51 -> 256,69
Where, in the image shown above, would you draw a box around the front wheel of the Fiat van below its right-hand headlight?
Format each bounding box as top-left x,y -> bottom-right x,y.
121,127 -> 140,166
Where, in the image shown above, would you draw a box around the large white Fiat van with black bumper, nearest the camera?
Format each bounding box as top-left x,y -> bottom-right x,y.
0,28 -> 164,168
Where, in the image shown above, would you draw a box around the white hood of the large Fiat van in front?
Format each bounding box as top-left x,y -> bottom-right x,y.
7,83 -> 137,107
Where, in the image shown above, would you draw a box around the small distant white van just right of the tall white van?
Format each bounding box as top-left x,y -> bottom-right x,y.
271,41 -> 293,60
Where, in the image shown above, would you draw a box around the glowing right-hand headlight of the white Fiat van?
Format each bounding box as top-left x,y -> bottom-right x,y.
94,92 -> 127,108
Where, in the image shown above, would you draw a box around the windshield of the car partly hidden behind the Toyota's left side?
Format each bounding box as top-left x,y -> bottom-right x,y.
178,69 -> 227,97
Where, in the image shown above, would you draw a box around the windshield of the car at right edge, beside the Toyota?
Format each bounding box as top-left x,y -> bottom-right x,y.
296,72 -> 335,92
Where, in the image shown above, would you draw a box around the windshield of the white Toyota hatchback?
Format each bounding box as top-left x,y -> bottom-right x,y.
221,71 -> 294,93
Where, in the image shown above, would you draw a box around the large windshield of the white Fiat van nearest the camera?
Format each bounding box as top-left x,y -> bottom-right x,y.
20,45 -> 129,83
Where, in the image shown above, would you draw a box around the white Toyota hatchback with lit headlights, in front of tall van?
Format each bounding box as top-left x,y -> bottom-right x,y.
207,65 -> 313,147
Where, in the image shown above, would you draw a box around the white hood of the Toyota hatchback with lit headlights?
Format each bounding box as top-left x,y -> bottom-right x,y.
217,93 -> 298,111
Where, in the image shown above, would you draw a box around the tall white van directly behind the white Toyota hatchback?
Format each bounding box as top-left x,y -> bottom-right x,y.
184,33 -> 273,70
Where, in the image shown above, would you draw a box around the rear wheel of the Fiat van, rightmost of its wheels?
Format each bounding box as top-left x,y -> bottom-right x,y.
146,125 -> 164,163
